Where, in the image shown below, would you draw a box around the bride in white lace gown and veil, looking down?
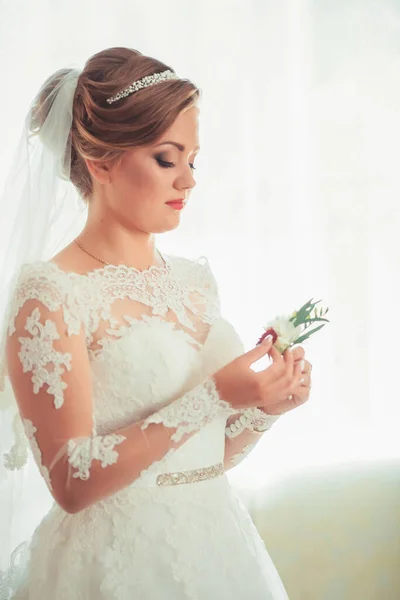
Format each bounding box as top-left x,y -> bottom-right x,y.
0,48 -> 311,600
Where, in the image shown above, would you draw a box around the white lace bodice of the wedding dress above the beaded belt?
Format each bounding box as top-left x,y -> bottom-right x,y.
10,257 -> 247,485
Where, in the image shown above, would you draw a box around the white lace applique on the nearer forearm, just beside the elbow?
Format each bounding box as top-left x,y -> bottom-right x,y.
67,433 -> 126,481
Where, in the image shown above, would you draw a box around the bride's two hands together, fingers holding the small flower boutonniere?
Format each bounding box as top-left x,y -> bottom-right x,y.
213,336 -> 304,415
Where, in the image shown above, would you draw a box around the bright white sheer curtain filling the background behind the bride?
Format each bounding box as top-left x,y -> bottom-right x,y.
0,0 -> 400,490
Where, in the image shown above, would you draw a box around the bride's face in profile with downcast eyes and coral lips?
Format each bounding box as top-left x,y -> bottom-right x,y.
101,106 -> 199,233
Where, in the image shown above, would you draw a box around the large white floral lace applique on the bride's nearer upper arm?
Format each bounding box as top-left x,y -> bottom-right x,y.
18,308 -> 72,408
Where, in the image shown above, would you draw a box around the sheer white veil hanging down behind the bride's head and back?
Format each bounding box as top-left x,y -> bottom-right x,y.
0,69 -> 87,588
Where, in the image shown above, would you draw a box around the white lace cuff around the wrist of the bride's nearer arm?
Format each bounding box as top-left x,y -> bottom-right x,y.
141,378 -> 236,442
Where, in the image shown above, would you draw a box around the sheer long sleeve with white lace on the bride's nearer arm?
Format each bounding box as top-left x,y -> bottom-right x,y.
7,279 -> 233,513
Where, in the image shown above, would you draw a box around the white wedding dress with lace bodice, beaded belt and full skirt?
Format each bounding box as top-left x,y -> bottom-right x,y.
0,256 -> 287,600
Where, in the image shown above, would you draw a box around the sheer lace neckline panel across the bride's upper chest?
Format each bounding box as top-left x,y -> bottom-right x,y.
49,258 -> 219,355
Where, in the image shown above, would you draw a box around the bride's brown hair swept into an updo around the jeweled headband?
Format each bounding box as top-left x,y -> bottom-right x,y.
31,48 -> 200,201
